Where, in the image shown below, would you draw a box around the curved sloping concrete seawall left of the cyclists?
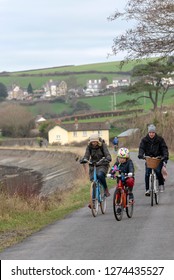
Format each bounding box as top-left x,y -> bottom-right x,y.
0,148 -> 85,196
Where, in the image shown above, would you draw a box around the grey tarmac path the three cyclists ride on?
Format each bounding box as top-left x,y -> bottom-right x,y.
0,153 -> 174,260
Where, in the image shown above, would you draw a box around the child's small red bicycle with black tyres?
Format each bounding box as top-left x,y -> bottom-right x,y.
108,171 -> 134,221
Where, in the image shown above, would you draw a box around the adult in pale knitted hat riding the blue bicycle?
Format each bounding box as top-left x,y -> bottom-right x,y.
81,133 -> 112,196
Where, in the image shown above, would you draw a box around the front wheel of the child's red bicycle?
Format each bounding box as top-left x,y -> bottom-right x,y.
113,189 -> 123,221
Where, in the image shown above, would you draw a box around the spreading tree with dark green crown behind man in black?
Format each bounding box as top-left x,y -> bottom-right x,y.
118,61 -> 173,110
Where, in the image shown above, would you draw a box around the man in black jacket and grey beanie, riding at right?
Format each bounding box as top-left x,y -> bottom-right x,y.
138,124 -> 169,196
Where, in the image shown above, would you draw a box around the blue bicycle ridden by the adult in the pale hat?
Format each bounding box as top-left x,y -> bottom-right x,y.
80,158 -> 106,217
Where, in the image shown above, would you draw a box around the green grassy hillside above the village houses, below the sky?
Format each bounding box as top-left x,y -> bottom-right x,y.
0,60 -> 154,89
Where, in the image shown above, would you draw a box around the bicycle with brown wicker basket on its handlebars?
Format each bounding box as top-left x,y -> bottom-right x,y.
144,156 -> 161,206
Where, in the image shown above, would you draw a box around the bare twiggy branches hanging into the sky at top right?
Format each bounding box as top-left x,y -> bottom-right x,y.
109,0 -> 174,61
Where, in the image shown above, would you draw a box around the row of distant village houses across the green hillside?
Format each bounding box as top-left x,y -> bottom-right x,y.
7,77 -> 174,101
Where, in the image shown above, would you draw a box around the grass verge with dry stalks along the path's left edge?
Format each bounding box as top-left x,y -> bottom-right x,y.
0,179 -> 113,251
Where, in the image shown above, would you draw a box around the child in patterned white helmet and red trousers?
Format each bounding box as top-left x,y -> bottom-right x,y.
109,148 -> 135,203
